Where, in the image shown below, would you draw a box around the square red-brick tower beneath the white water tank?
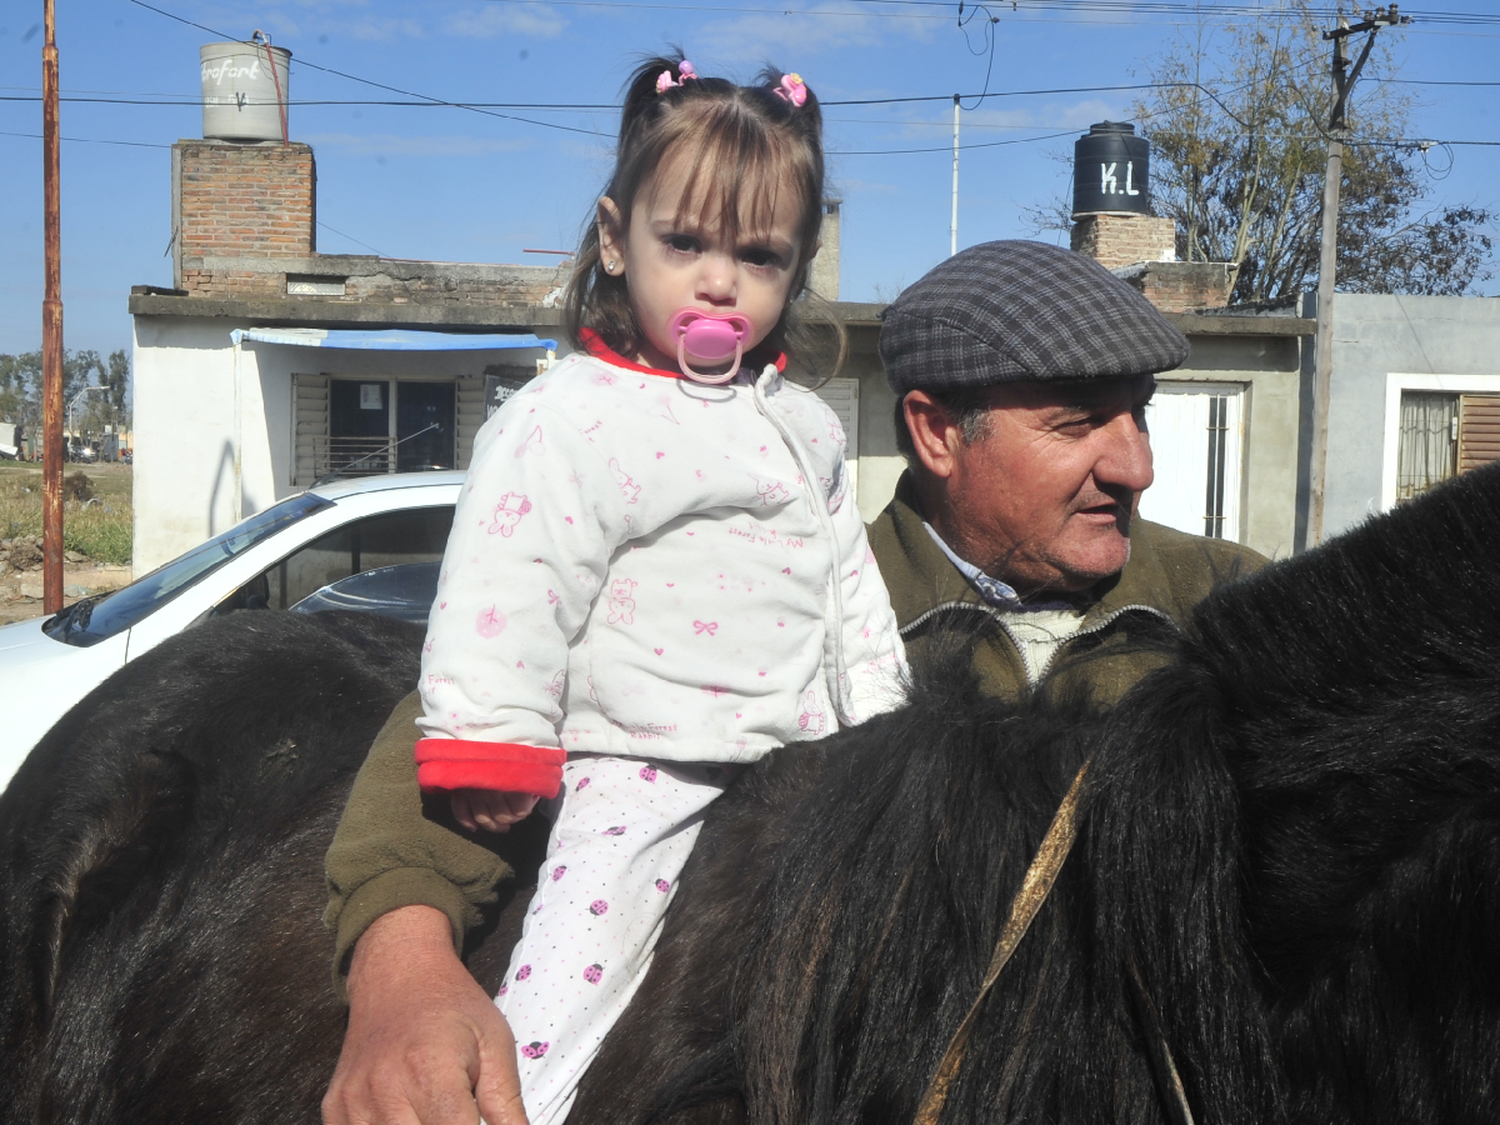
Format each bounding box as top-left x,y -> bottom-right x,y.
173,140 -> 318,297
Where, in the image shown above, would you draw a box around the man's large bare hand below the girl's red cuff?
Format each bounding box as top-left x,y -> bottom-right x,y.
323,906 -> 527,1125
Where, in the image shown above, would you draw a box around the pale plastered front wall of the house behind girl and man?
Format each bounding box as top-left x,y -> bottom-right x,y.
134,302 -> 1314,573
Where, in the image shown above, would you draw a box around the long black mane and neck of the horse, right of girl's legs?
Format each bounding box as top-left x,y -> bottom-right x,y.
633,468 -> 1500,1125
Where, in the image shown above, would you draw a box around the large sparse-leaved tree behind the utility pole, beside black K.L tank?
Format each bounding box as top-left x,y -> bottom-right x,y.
1134,0 -> 1493,302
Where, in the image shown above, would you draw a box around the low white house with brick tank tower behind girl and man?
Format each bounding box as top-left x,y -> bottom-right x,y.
129,140 -> 1311,573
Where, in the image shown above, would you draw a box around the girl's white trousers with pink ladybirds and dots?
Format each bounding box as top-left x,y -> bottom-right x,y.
495,755 -> 737,1125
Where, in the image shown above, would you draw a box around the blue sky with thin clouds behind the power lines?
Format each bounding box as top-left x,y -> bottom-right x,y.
0,0 -> 1500,361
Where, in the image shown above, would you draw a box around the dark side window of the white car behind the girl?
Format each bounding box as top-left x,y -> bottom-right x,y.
215,504 -> 453,617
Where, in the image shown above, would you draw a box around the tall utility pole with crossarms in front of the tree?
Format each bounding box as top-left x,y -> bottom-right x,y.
1308,5 -> 1412,546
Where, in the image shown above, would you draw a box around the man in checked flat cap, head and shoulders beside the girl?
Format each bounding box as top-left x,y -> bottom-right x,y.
870,242 -> 1263,701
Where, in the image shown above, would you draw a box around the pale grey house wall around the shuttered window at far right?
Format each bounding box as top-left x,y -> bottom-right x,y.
1326,293 -> 1500,537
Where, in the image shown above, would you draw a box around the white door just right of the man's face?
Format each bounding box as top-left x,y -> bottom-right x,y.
1140,383 -> 1245,542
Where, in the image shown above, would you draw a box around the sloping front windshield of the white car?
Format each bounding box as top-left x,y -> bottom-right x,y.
42,492 -> 333,648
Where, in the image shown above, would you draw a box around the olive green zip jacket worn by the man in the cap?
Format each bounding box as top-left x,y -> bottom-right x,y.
324,474 -> 1265,995
